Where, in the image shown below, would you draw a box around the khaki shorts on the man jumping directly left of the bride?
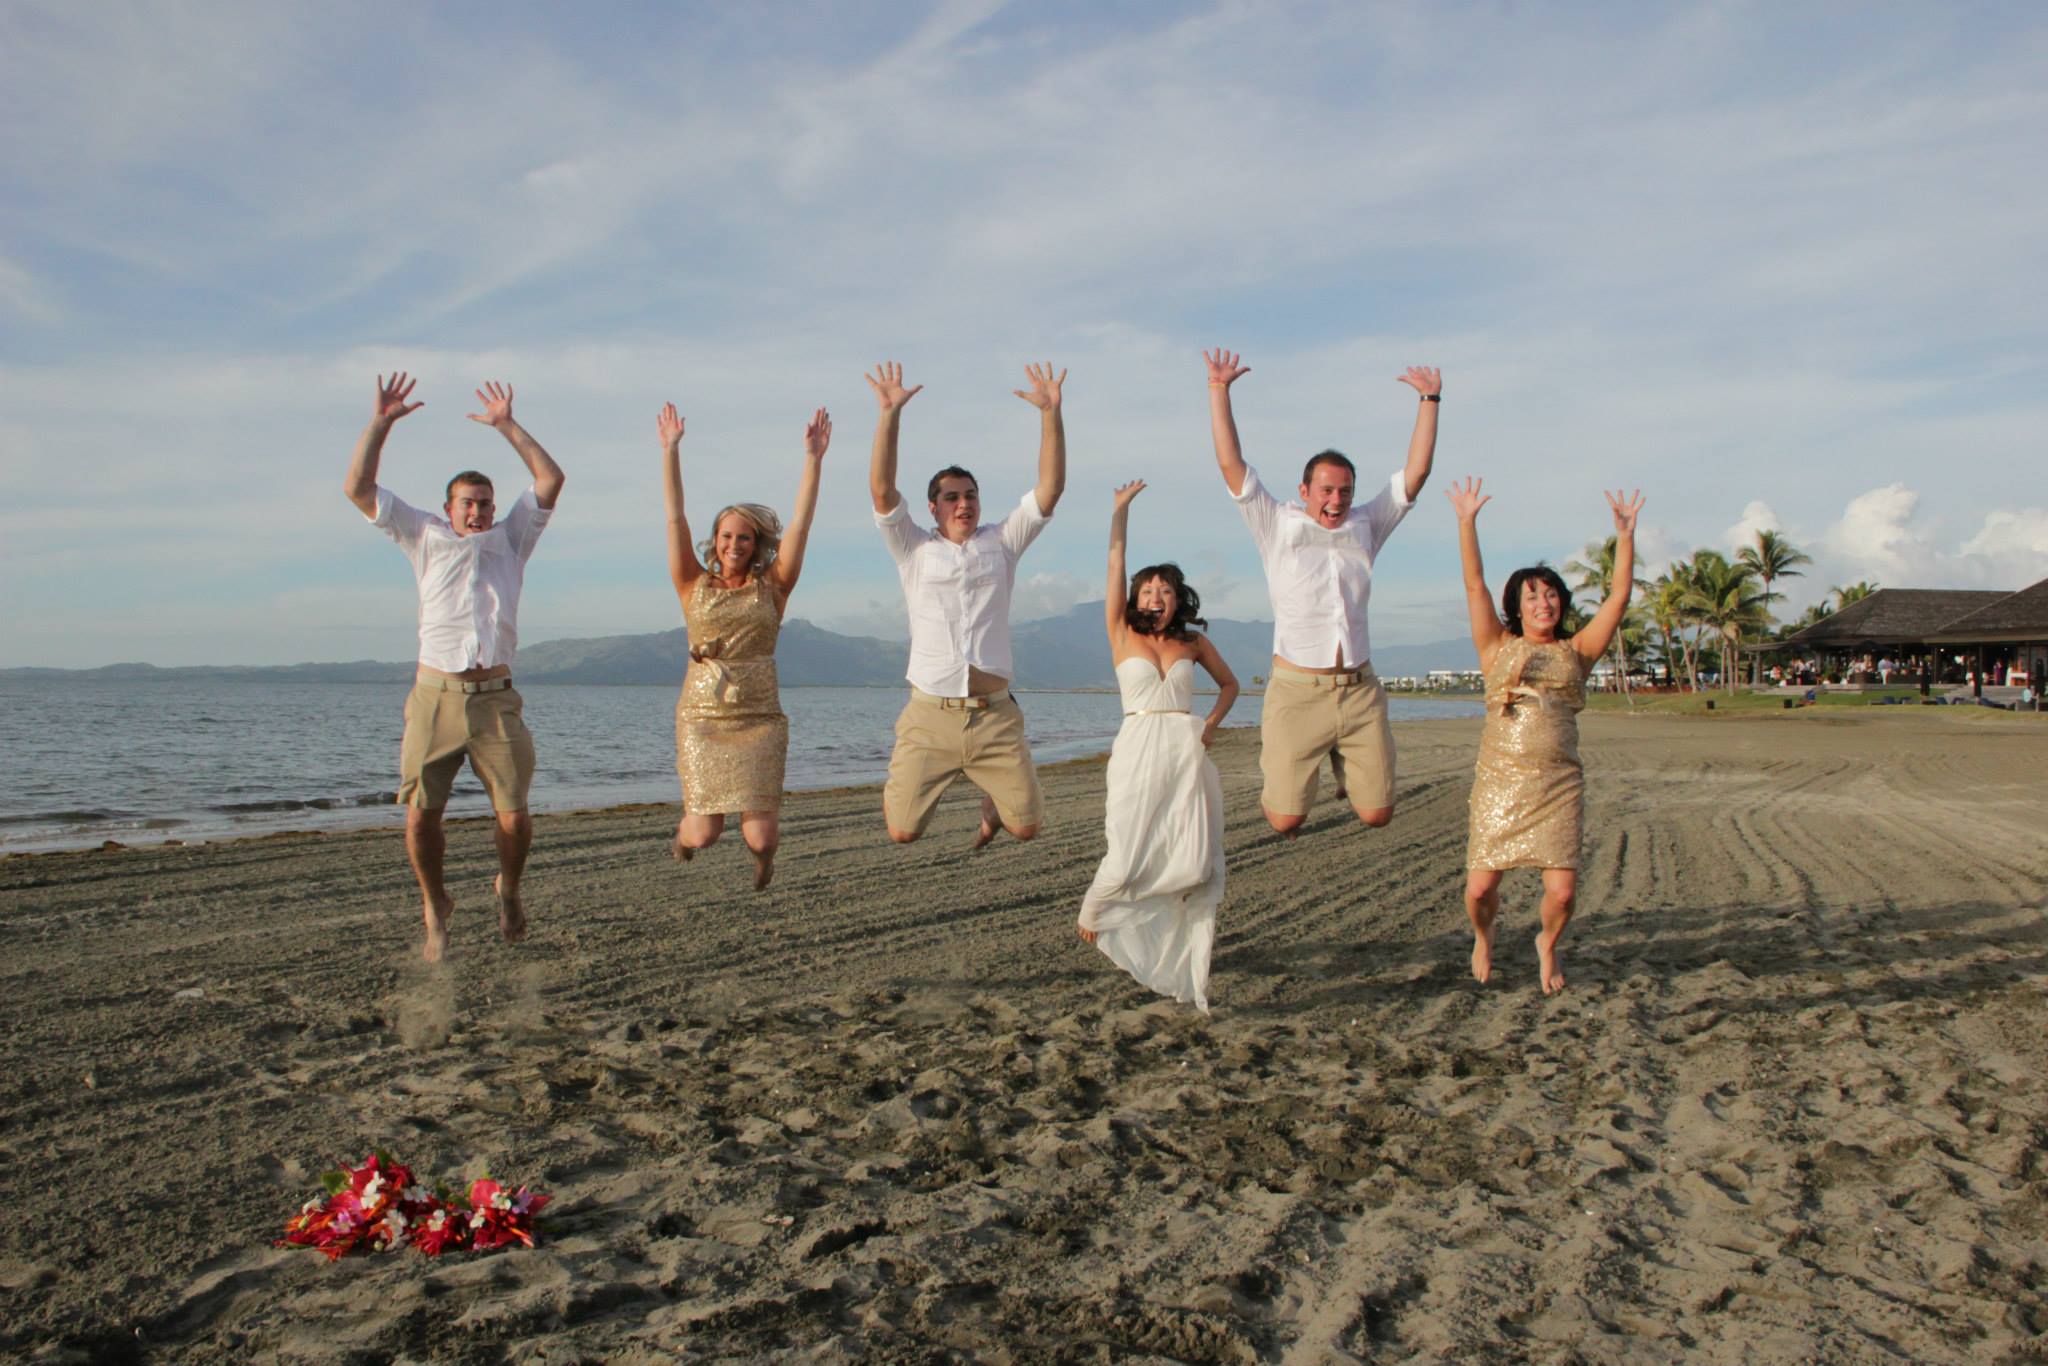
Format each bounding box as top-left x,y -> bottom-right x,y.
883,688 -> 1044,836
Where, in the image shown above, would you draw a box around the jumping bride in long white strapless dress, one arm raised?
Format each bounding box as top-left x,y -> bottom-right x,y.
1079,481 -> 1237,1014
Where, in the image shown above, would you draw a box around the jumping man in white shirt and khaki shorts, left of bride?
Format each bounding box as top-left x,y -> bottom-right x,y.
866,360 -> 1067,850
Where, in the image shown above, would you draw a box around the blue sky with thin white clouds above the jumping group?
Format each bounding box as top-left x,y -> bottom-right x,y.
0,0 -> 2048,668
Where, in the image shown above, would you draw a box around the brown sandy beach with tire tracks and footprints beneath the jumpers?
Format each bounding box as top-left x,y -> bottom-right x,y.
0,709 -> 2048,1366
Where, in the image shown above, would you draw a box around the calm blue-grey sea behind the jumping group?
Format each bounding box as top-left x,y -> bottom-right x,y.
0,680 -> 1481,852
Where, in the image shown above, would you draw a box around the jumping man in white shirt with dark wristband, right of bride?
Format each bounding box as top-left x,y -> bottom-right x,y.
1202,350 -> 1444,838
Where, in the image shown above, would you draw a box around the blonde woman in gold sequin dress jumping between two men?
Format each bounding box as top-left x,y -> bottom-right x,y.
655,403 -> 831,891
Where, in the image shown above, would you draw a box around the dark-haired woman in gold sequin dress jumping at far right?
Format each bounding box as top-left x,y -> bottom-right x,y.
1450,479 -> 1642,995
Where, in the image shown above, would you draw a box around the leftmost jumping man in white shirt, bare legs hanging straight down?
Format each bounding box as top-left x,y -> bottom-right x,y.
342,375 -> 563,963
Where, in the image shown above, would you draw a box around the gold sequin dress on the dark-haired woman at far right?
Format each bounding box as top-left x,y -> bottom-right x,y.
1464,635 -> 1585,868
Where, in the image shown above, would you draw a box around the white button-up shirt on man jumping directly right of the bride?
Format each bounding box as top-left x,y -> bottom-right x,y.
1237,467 -> 1415,670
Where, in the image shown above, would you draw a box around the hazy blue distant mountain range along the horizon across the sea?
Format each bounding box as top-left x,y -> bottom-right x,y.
0,602 -> 1473,688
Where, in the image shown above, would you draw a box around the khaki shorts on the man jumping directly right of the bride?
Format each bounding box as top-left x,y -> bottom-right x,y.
1260,664 -> 1395,815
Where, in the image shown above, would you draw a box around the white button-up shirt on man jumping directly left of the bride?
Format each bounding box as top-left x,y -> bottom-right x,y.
874,489 -> 1053,696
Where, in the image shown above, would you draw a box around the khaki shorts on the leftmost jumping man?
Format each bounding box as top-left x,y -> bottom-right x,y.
397,676 -> 532,811
